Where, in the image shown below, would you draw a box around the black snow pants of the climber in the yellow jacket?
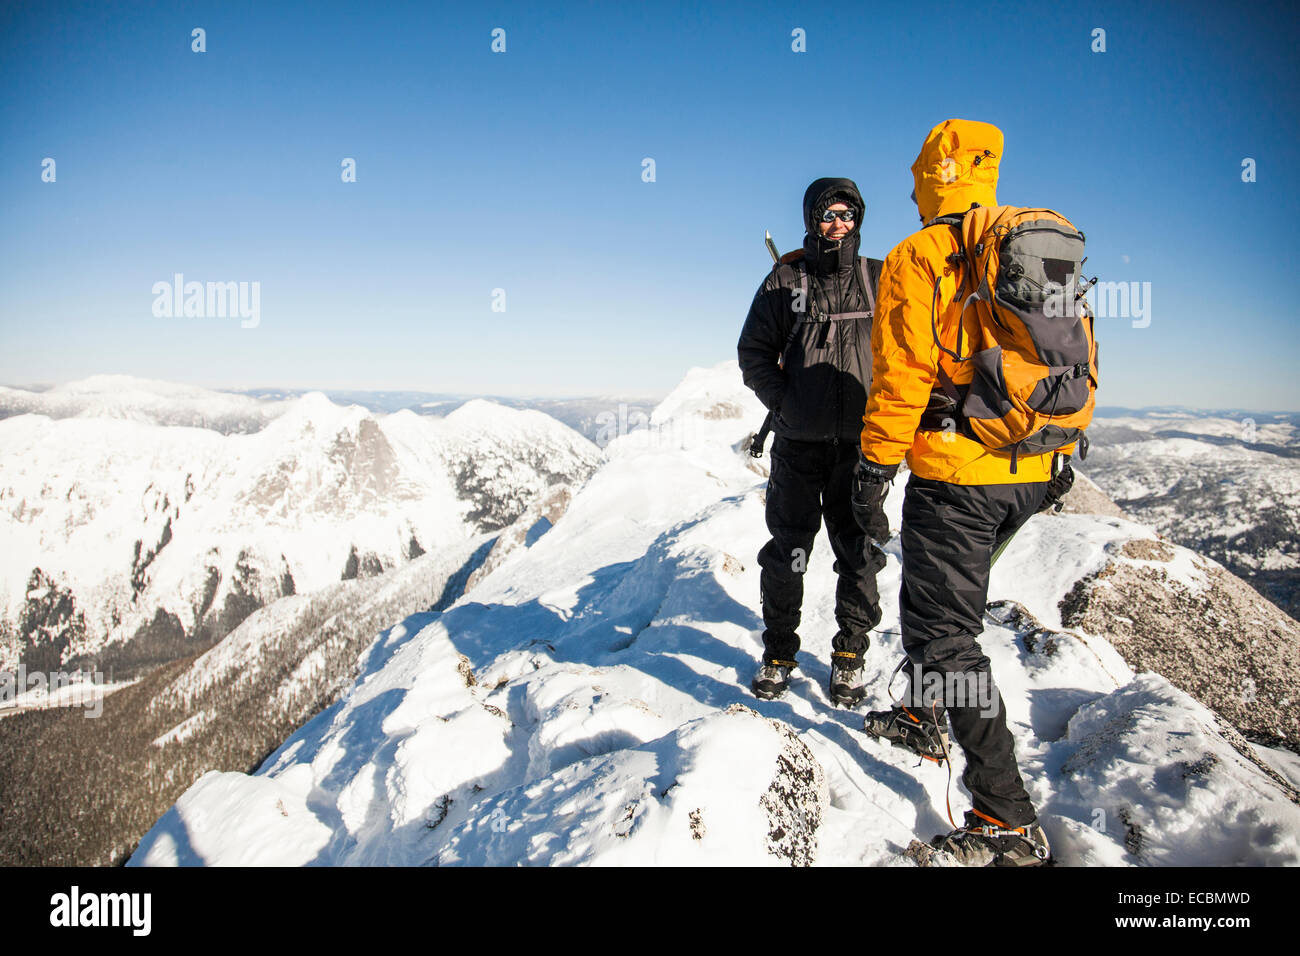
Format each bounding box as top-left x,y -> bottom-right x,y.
898,475 -> 1047,827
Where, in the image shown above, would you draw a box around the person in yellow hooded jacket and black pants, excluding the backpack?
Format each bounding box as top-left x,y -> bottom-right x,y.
854,120 -> 1070,865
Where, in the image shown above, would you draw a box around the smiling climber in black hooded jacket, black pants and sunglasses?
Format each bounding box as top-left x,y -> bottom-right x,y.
736,179 -> 889,706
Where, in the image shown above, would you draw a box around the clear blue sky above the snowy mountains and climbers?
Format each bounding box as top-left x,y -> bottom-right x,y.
0,3 -> 1300,410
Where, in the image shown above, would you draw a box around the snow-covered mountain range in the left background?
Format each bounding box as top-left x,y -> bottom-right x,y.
0,377 -> 599,670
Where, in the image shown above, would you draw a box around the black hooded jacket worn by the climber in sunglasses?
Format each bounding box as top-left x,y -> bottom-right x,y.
736,179 -> 881,444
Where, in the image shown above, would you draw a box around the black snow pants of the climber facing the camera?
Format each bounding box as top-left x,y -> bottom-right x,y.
758,437 -> 889,670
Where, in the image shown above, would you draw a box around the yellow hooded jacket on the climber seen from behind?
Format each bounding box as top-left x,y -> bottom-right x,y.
862,120 -> 1070,485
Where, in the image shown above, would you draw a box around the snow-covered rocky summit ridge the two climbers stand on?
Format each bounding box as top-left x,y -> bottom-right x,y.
133,363 -> 1300,865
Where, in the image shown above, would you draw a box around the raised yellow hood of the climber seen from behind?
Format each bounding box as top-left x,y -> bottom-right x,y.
911,120 -> 1002,222
